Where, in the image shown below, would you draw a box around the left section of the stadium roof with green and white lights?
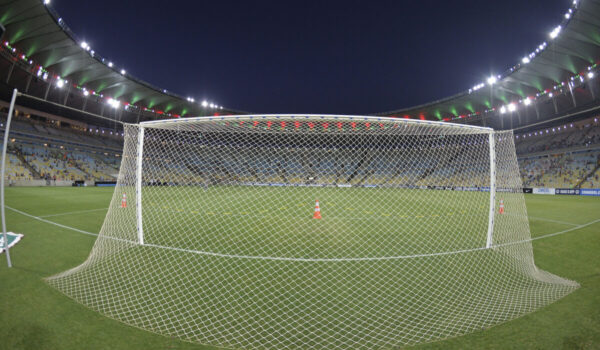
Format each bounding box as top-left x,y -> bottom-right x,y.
0,0 -> 243,126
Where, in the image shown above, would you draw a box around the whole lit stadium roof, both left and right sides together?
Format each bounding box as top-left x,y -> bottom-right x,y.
0,0 -> 600,128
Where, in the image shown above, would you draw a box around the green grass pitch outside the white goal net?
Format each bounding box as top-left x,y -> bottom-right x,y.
0,188 -> 600,349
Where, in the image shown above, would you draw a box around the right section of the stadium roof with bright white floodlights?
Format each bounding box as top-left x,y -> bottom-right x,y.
377,0 -> 600,127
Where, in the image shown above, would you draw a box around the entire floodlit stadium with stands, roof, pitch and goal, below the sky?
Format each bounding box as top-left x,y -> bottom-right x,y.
0,0 -> 600,349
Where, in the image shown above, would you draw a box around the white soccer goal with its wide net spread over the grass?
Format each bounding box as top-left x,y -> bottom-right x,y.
48,115 -> 578,349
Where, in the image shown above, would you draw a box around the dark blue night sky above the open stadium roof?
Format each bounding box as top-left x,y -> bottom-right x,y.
52,0 -> 571,114
